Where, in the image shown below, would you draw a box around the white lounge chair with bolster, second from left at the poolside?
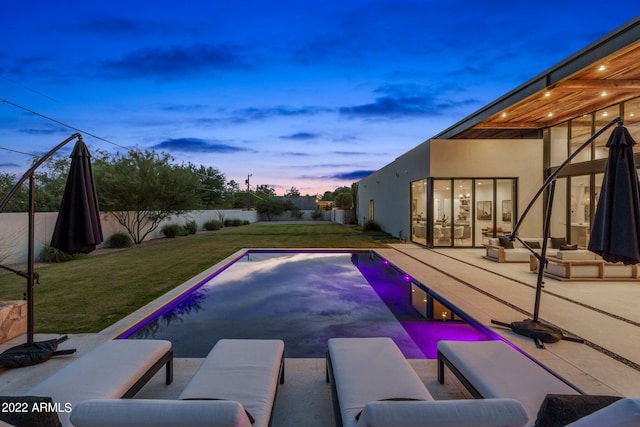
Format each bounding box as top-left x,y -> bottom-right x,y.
71,339 -> 284,427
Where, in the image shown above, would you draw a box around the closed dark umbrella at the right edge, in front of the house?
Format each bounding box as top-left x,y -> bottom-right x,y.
589,125 -> 640,264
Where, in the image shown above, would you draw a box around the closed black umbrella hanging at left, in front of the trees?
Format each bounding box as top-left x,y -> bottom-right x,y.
51,138 -> 102,254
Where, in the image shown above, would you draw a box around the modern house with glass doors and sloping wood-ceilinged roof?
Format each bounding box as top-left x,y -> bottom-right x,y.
358,17 -> 640,247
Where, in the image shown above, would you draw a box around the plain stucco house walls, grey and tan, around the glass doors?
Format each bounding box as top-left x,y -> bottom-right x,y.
358,139 -> 544,240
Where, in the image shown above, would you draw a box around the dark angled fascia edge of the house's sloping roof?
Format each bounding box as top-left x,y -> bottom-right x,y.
425,16 -> 640,142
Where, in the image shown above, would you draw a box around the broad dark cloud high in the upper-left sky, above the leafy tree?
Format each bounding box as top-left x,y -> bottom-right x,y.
102,44 -> 249,78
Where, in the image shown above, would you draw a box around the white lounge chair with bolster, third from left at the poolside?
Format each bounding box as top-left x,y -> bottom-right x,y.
327,338 -> 527,427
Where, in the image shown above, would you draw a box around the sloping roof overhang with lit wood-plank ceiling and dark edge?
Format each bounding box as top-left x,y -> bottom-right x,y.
434,17 -> 640,139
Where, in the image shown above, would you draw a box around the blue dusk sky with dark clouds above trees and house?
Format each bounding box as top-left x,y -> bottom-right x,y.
0,0 -> 640,194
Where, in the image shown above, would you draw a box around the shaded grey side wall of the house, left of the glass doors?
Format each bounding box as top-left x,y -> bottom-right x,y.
358,141 -> 430,240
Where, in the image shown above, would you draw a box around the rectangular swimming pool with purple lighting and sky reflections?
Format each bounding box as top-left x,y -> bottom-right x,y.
121,250 -> 494,359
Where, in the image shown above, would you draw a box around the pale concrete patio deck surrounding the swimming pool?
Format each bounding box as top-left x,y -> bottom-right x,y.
0,243 -> 640,427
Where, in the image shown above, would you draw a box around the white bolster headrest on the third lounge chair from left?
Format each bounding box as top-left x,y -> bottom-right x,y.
357,399 -> 527,427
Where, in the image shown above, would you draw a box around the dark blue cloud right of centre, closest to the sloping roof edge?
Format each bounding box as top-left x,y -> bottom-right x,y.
340,85 -> 479,119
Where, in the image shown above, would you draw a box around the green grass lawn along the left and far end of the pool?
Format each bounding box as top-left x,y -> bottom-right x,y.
0,223 -> 392,333
